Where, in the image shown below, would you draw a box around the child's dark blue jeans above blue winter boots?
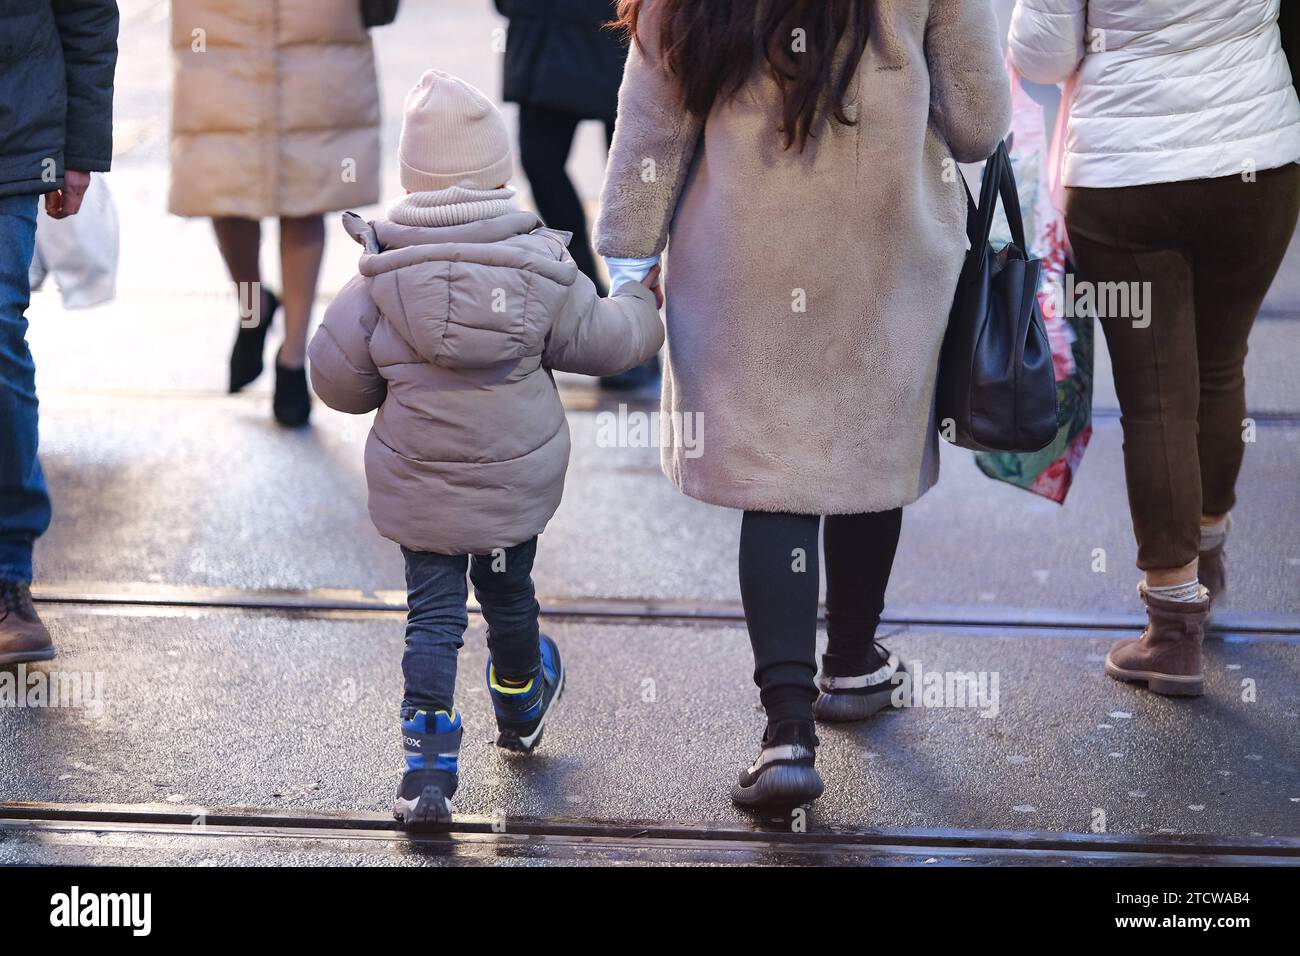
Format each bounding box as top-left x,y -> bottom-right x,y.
402,537 -> 542,718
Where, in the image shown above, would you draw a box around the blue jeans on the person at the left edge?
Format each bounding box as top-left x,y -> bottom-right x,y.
0,196 -> 49,581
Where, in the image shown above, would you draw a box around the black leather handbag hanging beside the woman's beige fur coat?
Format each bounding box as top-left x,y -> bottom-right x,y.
935,143 -> 1057,451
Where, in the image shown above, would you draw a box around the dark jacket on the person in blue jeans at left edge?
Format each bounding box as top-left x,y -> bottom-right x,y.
0,0 -> 117,196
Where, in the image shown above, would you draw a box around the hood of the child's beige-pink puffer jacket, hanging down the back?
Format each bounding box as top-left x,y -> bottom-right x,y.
343,212 -> 577,368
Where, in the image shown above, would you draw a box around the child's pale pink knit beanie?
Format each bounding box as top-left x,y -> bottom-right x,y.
398,70 -> 515,193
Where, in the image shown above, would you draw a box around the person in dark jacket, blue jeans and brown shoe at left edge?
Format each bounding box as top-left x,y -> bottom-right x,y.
0,0 -> 118,666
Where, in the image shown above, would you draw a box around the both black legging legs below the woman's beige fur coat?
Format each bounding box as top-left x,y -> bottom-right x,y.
740,509 -> 902,723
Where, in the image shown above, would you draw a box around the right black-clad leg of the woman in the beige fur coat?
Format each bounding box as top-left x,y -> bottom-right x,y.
822,507 -> 902,678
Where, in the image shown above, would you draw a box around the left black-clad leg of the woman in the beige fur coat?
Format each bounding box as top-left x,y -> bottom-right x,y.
740,511 -> 822,724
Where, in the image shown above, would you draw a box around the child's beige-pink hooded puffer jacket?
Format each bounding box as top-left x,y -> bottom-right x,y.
309,212 -> 663,554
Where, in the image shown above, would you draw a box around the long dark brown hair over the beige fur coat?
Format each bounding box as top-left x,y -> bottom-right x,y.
614,0 -> 871,152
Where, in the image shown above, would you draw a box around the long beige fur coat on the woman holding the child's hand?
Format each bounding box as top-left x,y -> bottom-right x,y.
597,0 -> 1010,514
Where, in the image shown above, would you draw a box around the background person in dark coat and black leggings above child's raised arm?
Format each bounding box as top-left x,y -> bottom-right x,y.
494,0 -> 659,389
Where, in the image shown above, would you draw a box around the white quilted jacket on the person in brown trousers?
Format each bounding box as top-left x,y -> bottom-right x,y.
1010,0 -> 1300,187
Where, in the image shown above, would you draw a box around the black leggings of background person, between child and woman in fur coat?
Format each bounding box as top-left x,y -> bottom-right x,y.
519,107 -> 614,297
